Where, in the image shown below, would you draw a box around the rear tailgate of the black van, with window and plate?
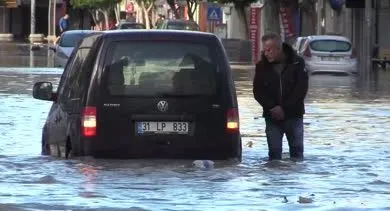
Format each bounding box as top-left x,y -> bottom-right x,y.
97,41 -> 227,153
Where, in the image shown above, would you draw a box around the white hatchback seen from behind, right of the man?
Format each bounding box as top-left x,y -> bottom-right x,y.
300,35 -> 357,75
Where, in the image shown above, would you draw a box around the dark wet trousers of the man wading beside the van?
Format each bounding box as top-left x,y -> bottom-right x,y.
265,118 -> 303,160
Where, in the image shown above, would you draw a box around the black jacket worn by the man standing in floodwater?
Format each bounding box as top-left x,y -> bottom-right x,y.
253,44 -> 308,118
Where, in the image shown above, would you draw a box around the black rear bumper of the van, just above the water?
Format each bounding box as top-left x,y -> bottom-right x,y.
81,134 -> 242,160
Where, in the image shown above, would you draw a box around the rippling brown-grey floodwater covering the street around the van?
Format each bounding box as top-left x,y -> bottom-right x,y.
0,44 -> 390,211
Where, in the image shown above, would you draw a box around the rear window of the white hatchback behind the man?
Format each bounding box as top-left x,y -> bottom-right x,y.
310,40 -> 351,52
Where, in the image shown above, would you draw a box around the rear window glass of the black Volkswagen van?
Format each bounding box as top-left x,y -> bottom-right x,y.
104,41 -> 217,96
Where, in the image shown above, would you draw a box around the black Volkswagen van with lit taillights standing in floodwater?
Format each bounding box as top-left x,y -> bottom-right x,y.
33,30 -> 242,160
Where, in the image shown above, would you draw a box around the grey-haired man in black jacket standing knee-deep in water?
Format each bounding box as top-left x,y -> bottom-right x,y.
253,33 -> 308,160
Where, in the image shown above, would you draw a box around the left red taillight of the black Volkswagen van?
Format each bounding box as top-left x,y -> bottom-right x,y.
81,106 -> 96,137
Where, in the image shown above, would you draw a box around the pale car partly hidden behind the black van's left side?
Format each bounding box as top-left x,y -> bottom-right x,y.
49,30 -> 94,67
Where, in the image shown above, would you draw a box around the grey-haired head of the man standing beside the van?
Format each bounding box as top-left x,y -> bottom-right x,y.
261,32 -> 283,62
